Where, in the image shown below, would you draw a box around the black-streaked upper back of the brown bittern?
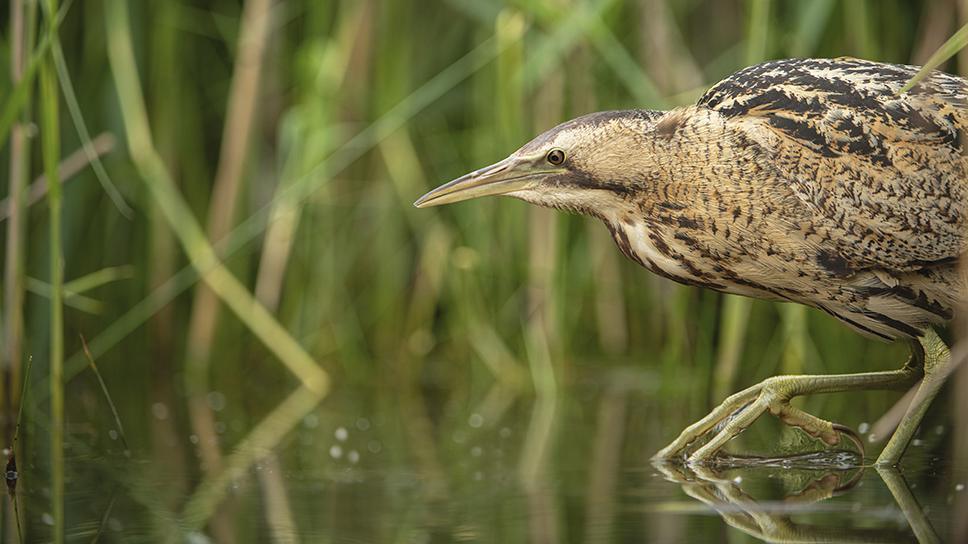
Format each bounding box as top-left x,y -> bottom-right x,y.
697,57 -> 968,158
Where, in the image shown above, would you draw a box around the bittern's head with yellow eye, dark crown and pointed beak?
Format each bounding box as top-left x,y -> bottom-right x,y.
414,110 -> 660,215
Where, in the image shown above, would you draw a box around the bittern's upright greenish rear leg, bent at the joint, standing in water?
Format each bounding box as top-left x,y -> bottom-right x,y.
877,329 -> 952,466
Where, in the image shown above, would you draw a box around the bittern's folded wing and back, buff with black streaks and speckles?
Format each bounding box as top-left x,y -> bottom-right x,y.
697,58 -> 968,271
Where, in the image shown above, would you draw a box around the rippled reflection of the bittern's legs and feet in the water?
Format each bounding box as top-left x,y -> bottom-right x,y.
653,451 -> 940,544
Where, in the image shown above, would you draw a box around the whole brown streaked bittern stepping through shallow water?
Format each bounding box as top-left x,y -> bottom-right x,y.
414,57 -> 968,465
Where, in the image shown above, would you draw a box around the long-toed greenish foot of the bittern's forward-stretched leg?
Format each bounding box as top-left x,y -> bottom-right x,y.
655,376 -> 864,465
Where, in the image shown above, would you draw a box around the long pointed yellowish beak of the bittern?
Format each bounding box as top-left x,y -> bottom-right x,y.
413,157 -> 554,208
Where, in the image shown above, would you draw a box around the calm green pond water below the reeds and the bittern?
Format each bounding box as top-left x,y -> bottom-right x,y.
17,362 -> 968,543
